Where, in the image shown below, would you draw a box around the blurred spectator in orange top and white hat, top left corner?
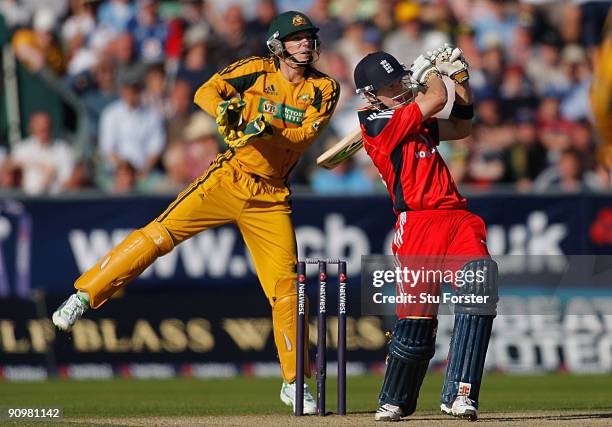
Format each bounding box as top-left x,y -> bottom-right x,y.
12,9 -> 64,75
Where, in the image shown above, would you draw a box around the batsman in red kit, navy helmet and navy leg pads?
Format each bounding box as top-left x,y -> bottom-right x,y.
354,45 -> 498,421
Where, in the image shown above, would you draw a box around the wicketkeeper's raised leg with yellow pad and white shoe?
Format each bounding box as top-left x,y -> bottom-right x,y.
53,155 -> 239,322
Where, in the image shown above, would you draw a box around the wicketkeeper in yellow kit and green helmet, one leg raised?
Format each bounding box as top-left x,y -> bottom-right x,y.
53,11 -> 340,414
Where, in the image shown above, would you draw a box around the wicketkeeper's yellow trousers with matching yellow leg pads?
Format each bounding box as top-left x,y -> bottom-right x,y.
75,152 -> 308,382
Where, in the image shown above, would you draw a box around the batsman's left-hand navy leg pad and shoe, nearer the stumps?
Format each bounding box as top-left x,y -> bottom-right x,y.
375,318 -> 438,421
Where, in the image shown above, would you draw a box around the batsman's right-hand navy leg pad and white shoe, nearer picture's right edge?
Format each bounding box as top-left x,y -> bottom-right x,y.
441,258 -> 498,419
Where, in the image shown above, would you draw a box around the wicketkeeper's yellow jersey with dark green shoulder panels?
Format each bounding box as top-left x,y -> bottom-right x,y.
194,57 -> 340,179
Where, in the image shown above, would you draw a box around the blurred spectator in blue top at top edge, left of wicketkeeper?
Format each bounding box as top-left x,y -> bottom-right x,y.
127,0 -> 168,64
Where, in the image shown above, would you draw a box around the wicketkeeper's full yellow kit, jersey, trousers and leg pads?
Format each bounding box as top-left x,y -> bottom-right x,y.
75,57 -> 340,382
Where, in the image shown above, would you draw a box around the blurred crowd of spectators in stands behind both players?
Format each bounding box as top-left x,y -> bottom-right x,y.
0,0 -> 612,194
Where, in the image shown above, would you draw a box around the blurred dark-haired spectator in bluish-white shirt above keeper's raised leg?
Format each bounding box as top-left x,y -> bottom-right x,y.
100,70 -> 166,178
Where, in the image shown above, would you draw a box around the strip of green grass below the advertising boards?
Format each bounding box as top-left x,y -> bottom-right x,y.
0,374 -> 612,426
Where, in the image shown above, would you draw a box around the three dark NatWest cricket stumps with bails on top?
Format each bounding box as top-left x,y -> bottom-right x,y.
295,259 -> 346,416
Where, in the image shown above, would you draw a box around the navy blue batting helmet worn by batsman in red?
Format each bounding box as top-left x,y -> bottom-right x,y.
354,52 -> 409,93
